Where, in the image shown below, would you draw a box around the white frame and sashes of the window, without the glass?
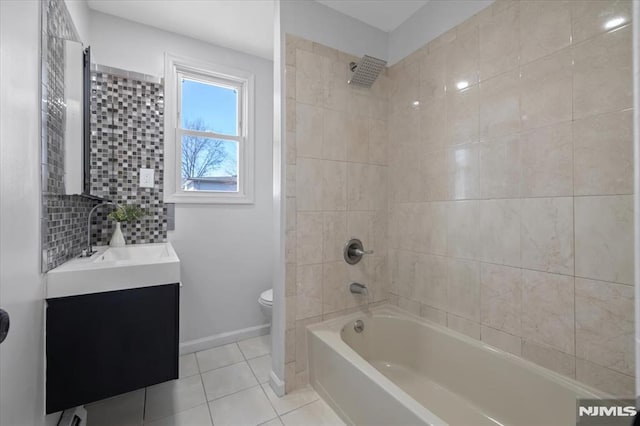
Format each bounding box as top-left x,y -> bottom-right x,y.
164,53 -> 255,204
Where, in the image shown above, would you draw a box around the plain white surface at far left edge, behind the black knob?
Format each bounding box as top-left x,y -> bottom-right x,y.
0,0 -> 44,426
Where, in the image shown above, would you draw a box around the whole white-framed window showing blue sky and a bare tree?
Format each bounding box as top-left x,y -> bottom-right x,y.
165,55 -> 253,203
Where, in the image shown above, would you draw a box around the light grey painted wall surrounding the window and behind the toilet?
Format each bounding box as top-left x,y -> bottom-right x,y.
90,11 -> 273,348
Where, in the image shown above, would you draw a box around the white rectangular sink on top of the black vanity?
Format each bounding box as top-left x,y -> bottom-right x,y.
46,243 -> 180,299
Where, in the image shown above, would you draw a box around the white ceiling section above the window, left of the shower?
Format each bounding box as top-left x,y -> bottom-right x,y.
85,0 -> 274,59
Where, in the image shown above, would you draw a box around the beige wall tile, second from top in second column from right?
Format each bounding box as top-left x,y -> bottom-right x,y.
521,49 -> 573,129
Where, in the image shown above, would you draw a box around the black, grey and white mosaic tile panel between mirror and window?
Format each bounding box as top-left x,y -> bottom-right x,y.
91,69 -> 167,245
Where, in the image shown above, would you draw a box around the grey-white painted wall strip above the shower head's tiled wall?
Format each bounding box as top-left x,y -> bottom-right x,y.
280,0 -> 388,60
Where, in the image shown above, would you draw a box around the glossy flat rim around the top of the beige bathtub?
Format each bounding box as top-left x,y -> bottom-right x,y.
307,304 -> 608,416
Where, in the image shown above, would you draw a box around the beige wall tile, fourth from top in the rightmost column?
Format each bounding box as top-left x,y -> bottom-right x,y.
575,195 -> 633,284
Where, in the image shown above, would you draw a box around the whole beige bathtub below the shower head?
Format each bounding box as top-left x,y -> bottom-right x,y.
307,306 -> 608,426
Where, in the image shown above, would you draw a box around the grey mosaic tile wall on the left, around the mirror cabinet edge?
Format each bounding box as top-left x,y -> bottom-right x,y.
41,0 -> 95,271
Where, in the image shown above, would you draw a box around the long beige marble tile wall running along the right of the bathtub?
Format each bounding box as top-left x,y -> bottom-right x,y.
388,0 -> 634,396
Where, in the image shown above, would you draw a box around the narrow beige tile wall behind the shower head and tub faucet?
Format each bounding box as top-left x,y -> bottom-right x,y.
285,35 -> 388,391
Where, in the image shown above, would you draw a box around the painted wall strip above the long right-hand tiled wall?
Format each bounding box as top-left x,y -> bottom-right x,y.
388,0 -> 493,65
